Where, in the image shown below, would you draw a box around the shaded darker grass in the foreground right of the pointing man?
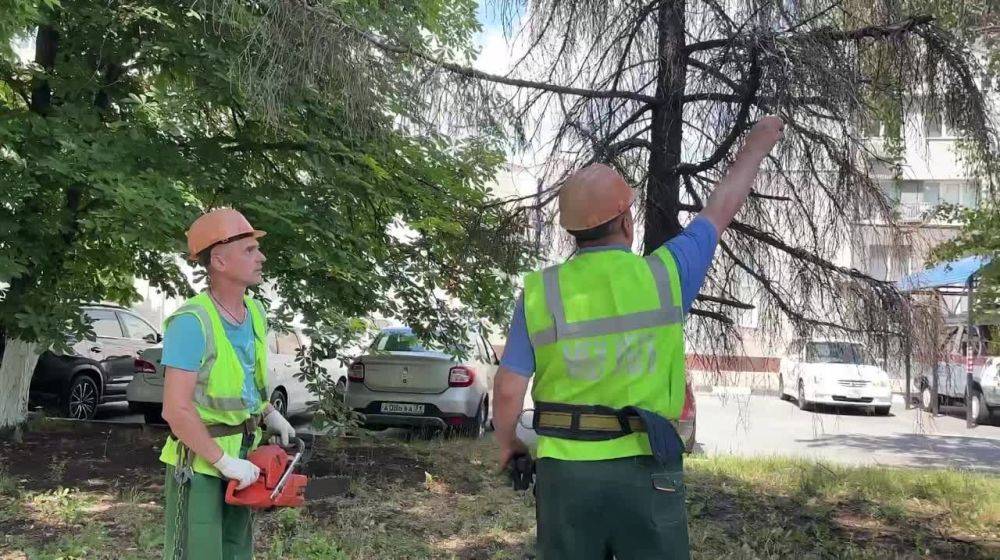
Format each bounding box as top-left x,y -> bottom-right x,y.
686,465 -> 1000,560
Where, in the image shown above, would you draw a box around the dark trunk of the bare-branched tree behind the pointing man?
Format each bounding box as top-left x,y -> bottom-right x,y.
643,0 -> 687,254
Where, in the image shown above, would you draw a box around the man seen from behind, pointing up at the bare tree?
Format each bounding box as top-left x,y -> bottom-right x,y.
493,117 -> 784,560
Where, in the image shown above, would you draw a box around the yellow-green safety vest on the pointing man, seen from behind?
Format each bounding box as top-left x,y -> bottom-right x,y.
524,247 -> 685,461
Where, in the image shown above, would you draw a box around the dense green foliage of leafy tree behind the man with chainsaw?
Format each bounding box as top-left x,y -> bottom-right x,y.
0,0 -> 527,429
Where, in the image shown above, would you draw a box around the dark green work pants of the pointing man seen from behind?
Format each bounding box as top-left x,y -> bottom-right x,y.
535,456 -> 691,560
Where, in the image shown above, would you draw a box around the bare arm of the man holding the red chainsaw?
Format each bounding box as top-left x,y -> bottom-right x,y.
163,367 -> 222,463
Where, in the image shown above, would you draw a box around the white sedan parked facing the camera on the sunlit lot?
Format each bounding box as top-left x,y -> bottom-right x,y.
778,339 -> 892,416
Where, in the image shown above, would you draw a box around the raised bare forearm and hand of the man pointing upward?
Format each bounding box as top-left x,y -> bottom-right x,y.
701,116 -> 785,235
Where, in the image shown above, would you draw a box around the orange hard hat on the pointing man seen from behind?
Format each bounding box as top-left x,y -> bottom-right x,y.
559,163 -> 635,231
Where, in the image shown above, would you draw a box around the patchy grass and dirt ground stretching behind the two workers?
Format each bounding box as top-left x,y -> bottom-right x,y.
0,422 -> 1000,560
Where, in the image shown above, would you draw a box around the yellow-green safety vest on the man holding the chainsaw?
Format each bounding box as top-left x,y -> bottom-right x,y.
160,292 -> 268,476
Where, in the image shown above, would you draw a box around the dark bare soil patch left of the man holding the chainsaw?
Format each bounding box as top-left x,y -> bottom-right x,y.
0,421 -> 166,492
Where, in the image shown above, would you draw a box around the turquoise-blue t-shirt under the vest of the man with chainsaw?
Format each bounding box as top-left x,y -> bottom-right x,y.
161,304 -> 260,410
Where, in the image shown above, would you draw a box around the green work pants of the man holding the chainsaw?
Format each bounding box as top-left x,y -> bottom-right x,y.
163,452 -> 254,560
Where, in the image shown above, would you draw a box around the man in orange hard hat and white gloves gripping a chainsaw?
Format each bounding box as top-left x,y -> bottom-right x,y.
160,208 -> 295,560
